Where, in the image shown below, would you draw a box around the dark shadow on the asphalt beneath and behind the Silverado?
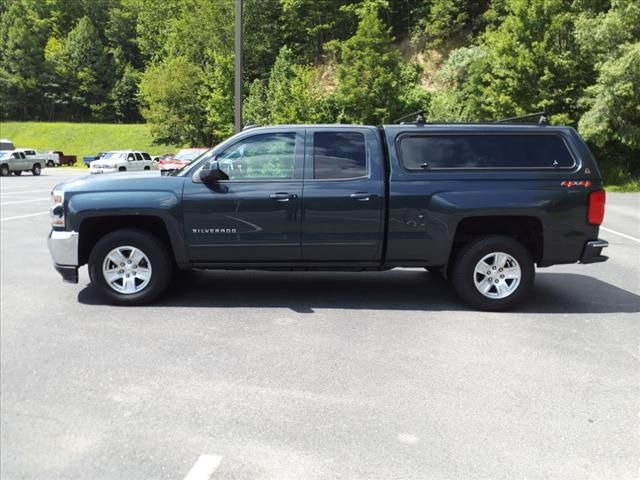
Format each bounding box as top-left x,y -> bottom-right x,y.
78,270 -> 640,313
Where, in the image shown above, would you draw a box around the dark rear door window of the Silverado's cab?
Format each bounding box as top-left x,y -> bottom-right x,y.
313,132 -> 367,179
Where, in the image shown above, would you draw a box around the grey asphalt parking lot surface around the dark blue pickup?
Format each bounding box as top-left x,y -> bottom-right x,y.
0,169 -> 640,480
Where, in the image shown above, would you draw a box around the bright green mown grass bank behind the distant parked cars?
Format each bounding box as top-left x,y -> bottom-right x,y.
0,122 -> 181,164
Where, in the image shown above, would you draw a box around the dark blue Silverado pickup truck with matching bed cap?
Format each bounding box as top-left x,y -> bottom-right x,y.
48,122 -> 608,310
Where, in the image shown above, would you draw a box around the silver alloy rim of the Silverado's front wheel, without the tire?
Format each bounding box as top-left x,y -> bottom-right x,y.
102,246 -> 151,295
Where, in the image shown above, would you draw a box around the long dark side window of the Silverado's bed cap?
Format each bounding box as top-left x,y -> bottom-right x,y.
399,135 -> 574,170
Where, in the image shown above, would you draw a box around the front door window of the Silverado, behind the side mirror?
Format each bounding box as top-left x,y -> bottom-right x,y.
218,133 -> 296,180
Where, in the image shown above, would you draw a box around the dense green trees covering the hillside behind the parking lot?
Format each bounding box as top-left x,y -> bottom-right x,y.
0,0 -> 640,186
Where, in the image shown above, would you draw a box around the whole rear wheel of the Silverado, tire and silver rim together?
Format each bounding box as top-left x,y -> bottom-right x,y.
451,235 -> 535,311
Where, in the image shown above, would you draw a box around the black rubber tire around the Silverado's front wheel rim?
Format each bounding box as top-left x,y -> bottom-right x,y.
88,229 -> 173,305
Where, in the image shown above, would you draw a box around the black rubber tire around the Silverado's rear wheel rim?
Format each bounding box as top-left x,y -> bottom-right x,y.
451,235 -> 535,311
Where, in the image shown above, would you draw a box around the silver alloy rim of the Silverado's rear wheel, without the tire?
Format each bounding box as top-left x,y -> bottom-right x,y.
473,252 -> 522,299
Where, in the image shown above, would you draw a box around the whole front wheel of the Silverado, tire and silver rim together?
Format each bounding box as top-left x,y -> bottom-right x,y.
88,229 -> 173,305
